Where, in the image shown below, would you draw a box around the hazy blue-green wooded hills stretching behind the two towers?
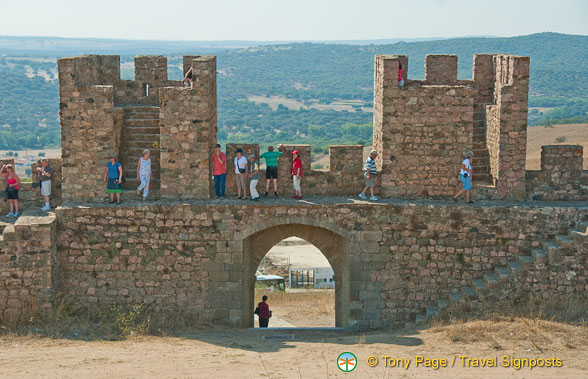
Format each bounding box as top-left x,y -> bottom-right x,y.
0,33 -> 588,151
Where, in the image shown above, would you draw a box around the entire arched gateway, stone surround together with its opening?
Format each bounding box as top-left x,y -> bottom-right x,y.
241,224 -> 350,327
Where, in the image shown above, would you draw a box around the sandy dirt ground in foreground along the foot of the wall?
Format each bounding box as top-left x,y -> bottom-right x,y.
0,319 -> 588,379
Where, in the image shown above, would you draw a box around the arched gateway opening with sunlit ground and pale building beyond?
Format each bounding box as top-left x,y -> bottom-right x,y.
254,237 -> 336,328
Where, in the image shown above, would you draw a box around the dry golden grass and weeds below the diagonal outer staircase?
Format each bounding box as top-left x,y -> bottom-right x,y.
430,296 -> 588,352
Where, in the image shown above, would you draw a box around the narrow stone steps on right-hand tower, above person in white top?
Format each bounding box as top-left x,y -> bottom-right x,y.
472,104 -> 493,184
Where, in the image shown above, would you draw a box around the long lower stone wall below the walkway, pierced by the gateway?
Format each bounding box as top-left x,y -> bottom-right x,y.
0,202 -> 588,328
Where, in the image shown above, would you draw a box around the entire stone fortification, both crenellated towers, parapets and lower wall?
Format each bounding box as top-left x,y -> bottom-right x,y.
0,55 -> 588,329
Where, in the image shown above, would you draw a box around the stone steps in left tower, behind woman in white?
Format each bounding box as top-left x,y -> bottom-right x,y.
121,105 -> 161,199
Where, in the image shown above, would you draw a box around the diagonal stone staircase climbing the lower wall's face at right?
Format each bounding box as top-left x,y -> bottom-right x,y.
405,221 -> 588,329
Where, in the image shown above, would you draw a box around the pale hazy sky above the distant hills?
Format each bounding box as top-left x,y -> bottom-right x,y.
0,0 -> 588,41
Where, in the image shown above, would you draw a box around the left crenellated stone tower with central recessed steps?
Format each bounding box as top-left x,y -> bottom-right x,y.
58,55 -> 217,202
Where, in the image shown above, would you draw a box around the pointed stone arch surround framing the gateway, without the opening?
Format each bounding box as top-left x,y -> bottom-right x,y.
241,219 -> 350,327
